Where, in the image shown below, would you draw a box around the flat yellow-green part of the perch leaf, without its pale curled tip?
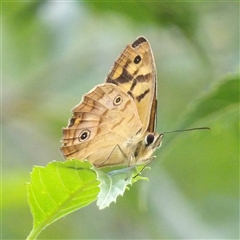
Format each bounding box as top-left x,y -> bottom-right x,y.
27,160 -> 99,239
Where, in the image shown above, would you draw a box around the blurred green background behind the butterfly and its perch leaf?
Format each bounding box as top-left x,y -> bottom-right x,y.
1,1 -> 239,239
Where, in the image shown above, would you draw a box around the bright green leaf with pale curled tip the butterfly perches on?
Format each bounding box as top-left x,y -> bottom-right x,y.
27,160 -> 149,239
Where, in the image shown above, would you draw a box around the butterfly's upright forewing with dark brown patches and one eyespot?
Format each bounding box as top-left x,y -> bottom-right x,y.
106,37 -> 157,132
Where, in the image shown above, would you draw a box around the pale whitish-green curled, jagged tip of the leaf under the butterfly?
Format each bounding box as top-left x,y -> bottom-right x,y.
97,166 -> 148,209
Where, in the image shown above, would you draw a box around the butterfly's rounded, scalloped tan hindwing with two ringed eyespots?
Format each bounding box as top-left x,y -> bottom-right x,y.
61,84 -> 142,167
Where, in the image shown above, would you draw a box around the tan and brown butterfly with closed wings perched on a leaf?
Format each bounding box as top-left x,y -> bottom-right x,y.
61,36 -> 163,167
